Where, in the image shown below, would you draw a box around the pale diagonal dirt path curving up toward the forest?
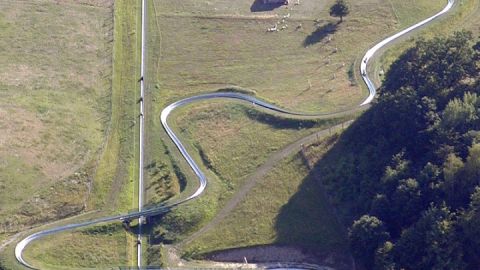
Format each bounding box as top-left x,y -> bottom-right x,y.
177,120 -> 352,247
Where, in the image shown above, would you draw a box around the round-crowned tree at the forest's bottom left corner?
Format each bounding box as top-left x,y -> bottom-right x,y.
349,215 -> 390,269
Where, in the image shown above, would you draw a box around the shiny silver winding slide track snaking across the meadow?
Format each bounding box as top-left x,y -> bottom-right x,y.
15,0 -> 455,269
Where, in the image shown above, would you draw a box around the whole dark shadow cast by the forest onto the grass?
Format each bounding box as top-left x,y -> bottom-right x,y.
268,116 -> 376,269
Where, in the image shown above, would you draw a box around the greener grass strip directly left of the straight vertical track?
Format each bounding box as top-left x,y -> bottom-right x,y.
89,1 -> 141,215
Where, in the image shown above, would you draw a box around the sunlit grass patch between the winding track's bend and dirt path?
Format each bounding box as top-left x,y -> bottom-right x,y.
172,101 -> 339,197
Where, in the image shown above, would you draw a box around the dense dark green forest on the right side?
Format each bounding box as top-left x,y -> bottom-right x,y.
316,32 -> 480,270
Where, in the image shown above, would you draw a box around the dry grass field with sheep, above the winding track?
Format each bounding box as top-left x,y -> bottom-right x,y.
150,0 -> 444,112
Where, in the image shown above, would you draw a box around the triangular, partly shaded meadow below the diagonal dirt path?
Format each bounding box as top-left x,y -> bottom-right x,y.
185,135 -> 348,260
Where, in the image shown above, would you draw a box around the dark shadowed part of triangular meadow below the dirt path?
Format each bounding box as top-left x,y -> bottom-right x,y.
275,166 -> 352,269
